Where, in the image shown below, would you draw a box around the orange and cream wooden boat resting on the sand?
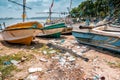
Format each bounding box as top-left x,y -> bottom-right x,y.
1,22 -> 42,45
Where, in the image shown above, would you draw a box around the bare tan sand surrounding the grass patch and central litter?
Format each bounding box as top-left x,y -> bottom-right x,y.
0,35 -> 120,80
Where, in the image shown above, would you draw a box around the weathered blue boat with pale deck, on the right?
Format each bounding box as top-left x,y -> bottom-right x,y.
72,25 -> 120,53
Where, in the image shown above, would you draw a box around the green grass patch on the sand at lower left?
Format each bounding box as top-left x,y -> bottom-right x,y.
0,51 -> 33,79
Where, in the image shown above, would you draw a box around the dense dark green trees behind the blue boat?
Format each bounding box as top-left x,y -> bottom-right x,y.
71,0 -> 120,18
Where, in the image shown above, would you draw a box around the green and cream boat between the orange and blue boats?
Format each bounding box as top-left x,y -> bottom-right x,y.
37,23 -> 65,38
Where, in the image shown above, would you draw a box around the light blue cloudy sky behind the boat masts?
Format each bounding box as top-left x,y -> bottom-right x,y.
0,0 -> 84,17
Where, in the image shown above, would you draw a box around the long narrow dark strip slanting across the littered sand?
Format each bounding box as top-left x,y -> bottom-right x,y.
47,43 -> 89,62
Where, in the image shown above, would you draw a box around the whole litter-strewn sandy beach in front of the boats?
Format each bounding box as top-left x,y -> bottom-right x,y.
0,29 -> 120,80
